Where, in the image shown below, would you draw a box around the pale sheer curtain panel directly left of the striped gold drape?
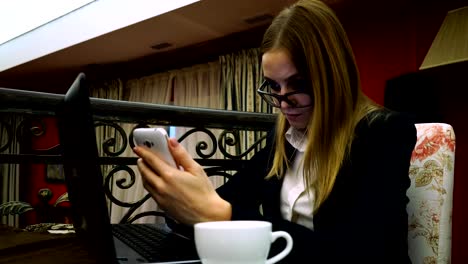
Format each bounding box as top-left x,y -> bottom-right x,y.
174,61 -> 224,187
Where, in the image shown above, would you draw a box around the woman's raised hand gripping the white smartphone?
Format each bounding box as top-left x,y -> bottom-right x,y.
133,138 -> 232,225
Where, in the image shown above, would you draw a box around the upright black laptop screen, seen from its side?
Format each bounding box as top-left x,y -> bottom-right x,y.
56,73 -> 115,263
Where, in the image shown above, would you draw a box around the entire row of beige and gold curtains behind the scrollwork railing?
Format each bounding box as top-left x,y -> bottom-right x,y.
90,49 -> 271,223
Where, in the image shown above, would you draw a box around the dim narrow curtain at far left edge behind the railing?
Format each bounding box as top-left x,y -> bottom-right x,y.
0,114 -> 23,227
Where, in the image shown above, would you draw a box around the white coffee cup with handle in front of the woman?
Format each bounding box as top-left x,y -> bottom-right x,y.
194,221 -> 293,264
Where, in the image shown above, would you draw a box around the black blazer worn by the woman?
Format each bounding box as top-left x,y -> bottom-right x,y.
217,110 -> 416,264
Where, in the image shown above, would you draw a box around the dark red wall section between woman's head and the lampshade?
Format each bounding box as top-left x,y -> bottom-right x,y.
343,7 -> 446,104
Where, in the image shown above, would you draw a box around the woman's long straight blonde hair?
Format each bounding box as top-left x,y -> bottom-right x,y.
262,0 -> 379,211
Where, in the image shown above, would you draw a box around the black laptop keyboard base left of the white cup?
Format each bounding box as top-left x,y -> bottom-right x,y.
112,224 -> 198,262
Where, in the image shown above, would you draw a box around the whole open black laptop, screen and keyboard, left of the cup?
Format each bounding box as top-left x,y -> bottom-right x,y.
56,73 -> 201,263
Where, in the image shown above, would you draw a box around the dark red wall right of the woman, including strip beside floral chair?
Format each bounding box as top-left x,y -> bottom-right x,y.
342,3 -> 468,264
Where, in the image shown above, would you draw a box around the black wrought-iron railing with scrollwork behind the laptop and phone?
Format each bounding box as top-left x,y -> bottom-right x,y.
0,88 -> 275,223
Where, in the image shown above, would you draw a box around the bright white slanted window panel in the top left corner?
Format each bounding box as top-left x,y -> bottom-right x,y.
0,0 -> 199,71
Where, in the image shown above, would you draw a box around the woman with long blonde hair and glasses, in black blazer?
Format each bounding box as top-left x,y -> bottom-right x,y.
135,0 -> 416,263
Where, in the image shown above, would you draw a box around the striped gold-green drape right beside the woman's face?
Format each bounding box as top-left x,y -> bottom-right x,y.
219,48 -> 272,158
